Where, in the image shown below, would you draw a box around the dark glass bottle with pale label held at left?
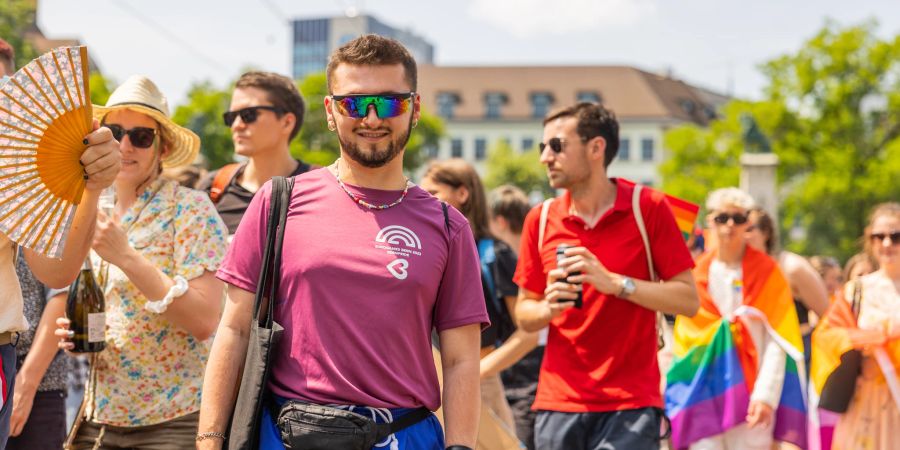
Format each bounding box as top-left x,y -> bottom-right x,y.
66,256 -> 106,353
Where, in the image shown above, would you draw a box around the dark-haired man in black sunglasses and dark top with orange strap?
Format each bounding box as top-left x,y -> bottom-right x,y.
197,72 -> 310,234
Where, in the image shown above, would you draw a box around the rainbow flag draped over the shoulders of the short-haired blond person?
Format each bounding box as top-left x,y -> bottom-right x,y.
665,246 -> 807,449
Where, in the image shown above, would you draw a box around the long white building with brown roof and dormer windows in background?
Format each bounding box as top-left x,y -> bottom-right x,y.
419,65 -> 728,186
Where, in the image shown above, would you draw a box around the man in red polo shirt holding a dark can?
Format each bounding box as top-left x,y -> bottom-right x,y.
515,103 -> 699,450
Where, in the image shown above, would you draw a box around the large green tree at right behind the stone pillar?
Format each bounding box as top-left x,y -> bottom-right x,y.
662,22 -> 900,257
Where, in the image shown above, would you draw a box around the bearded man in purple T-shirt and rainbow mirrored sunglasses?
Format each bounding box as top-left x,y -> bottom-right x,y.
198,35 -> 488,450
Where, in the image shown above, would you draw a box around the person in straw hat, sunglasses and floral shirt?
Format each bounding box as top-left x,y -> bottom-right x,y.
56,76 -> 227,449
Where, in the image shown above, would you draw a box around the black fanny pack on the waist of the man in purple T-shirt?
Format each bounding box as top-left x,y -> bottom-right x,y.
269,400 -> 431,450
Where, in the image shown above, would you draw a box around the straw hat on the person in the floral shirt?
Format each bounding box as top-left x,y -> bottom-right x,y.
94,75 -> 200,168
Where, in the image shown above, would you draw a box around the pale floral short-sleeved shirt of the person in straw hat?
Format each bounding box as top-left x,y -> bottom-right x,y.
87,179 -> 228,427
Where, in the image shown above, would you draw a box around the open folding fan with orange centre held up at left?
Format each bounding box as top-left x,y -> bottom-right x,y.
0,47 -> 92,258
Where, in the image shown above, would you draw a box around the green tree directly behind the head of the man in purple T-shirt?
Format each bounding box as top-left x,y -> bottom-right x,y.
291,73 -> 444,173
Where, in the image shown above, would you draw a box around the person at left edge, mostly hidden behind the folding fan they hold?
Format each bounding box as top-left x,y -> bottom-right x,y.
0,39 -> 121,448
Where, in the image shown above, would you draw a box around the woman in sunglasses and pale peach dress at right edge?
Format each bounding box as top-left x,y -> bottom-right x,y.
812,203 -> 900,450
